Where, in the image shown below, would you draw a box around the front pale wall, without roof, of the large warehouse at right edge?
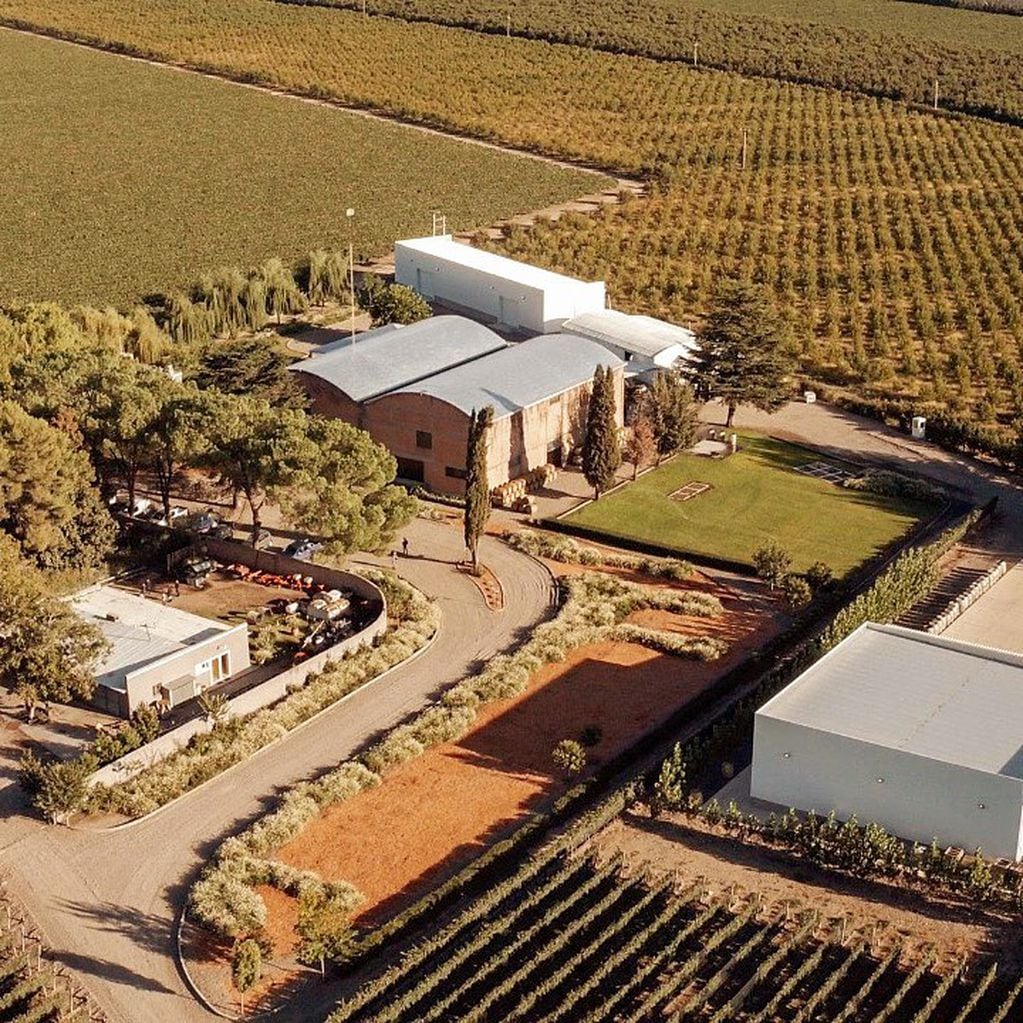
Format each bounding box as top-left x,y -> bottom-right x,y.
750,713 -> 1023,859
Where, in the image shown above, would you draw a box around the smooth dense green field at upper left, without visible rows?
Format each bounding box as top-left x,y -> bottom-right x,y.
0,30 -> 608,304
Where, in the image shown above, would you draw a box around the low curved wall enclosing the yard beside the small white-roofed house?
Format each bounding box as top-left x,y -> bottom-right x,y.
89,537 -> 387,786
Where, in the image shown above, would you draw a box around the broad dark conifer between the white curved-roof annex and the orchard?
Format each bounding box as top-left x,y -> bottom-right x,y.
696,280 -> 792,427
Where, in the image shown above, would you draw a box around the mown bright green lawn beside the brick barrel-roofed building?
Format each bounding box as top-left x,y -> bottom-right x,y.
565,434 -> 933,576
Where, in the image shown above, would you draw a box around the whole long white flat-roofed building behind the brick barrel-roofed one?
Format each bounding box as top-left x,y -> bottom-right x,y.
394,234 -> 606,333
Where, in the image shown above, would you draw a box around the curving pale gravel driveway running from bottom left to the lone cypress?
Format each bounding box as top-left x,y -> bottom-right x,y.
0,520 -> 551,1023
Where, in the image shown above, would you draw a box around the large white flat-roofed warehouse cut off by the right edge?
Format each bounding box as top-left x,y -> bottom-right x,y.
750,623 -> 1023,859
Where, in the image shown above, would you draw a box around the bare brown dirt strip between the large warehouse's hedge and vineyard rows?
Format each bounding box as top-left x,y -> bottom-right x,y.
590,814 -> 1023,971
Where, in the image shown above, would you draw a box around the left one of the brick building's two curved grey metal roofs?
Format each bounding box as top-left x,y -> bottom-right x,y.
291,316 -> 506,401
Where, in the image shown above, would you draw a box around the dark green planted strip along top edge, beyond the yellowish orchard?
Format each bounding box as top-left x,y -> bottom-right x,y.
276,0 -> 1023,121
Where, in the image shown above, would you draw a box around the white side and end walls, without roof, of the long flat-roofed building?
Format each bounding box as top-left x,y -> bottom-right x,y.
394,243 -> 605,333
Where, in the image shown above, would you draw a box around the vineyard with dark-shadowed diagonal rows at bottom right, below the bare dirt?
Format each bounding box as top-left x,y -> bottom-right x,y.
329,854 -> 1023,1023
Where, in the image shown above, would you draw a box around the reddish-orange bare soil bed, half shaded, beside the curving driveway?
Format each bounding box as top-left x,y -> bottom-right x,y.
268,589 -> 772,942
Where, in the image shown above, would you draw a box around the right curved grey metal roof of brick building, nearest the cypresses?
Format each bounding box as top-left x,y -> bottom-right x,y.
384,333 -> 625,419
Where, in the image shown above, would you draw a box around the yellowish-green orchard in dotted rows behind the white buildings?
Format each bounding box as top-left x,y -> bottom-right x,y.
6,0 -> 1023,427
